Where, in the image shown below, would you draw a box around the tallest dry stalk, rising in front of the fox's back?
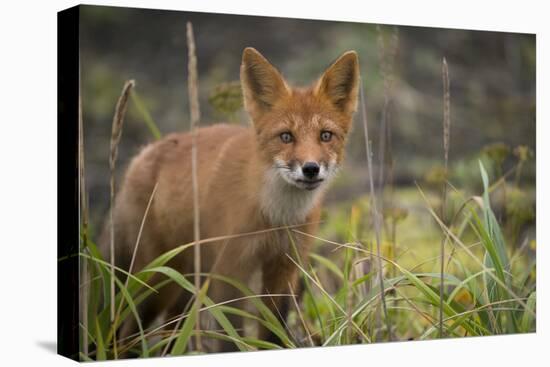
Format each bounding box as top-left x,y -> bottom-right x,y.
187,22 -> 202,351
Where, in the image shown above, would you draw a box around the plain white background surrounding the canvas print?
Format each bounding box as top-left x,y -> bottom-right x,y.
0,0 -> 550,367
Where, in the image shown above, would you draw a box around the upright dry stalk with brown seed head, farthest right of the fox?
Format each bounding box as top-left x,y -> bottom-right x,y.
439,58 -> 451,338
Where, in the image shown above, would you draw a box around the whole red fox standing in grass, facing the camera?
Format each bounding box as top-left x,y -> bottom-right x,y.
103,48 -> 360,351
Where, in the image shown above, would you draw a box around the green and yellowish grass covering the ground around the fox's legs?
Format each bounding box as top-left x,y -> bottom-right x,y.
81,159 -> 536,360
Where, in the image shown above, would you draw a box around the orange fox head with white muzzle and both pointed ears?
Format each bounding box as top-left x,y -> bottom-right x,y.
241,47 -> 359,191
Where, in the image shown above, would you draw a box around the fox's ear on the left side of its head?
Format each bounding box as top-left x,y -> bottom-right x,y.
241,47 -> 290,119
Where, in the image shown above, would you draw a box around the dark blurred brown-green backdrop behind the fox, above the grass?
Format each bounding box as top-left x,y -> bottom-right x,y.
80,6 -> 536,251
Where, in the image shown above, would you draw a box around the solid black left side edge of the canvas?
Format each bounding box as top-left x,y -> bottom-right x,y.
57,6 -> 80,360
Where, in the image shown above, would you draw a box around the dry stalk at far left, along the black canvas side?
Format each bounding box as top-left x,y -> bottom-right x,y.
78,72 -> 88,355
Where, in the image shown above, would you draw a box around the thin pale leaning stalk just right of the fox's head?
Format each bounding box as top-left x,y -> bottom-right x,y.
359,80 -> 391,340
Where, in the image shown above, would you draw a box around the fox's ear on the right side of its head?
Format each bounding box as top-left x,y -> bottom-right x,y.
315,51 -> 359,114
